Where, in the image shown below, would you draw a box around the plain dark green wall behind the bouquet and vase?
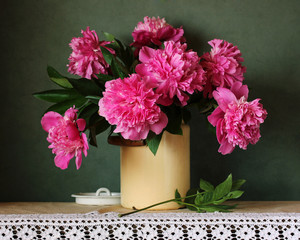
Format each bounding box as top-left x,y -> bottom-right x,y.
0,0 -> 300,201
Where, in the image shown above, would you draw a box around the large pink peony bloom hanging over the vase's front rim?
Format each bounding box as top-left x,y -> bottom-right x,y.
99,74 -> 168,140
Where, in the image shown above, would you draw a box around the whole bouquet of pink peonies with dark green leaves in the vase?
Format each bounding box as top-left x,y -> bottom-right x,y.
34,17 -> 267,169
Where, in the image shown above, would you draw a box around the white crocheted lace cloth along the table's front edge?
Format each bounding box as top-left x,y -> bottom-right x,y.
0,212 -> 300,240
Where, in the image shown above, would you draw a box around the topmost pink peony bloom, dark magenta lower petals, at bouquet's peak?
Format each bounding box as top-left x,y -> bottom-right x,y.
132,17 -> 185,53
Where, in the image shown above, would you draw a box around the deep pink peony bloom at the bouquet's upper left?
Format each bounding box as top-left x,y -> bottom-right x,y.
68,27 -> 114,79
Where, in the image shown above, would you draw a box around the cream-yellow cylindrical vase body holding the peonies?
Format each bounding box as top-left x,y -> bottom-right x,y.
121,125 -> 190,210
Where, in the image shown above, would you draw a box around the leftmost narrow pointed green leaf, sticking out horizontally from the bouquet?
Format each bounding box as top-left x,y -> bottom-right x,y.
33,89 -> 81,103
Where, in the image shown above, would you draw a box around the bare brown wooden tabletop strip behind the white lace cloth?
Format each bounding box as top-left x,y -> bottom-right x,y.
0,201 -> 300,214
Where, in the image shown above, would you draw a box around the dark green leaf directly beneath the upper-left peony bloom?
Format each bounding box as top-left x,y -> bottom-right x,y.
69,78 -> 102,96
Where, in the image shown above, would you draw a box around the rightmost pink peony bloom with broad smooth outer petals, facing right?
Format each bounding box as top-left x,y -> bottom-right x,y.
208,82 -> 267,155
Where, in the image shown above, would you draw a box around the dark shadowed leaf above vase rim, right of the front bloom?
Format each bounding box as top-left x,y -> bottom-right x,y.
163,105 -> 182,135
